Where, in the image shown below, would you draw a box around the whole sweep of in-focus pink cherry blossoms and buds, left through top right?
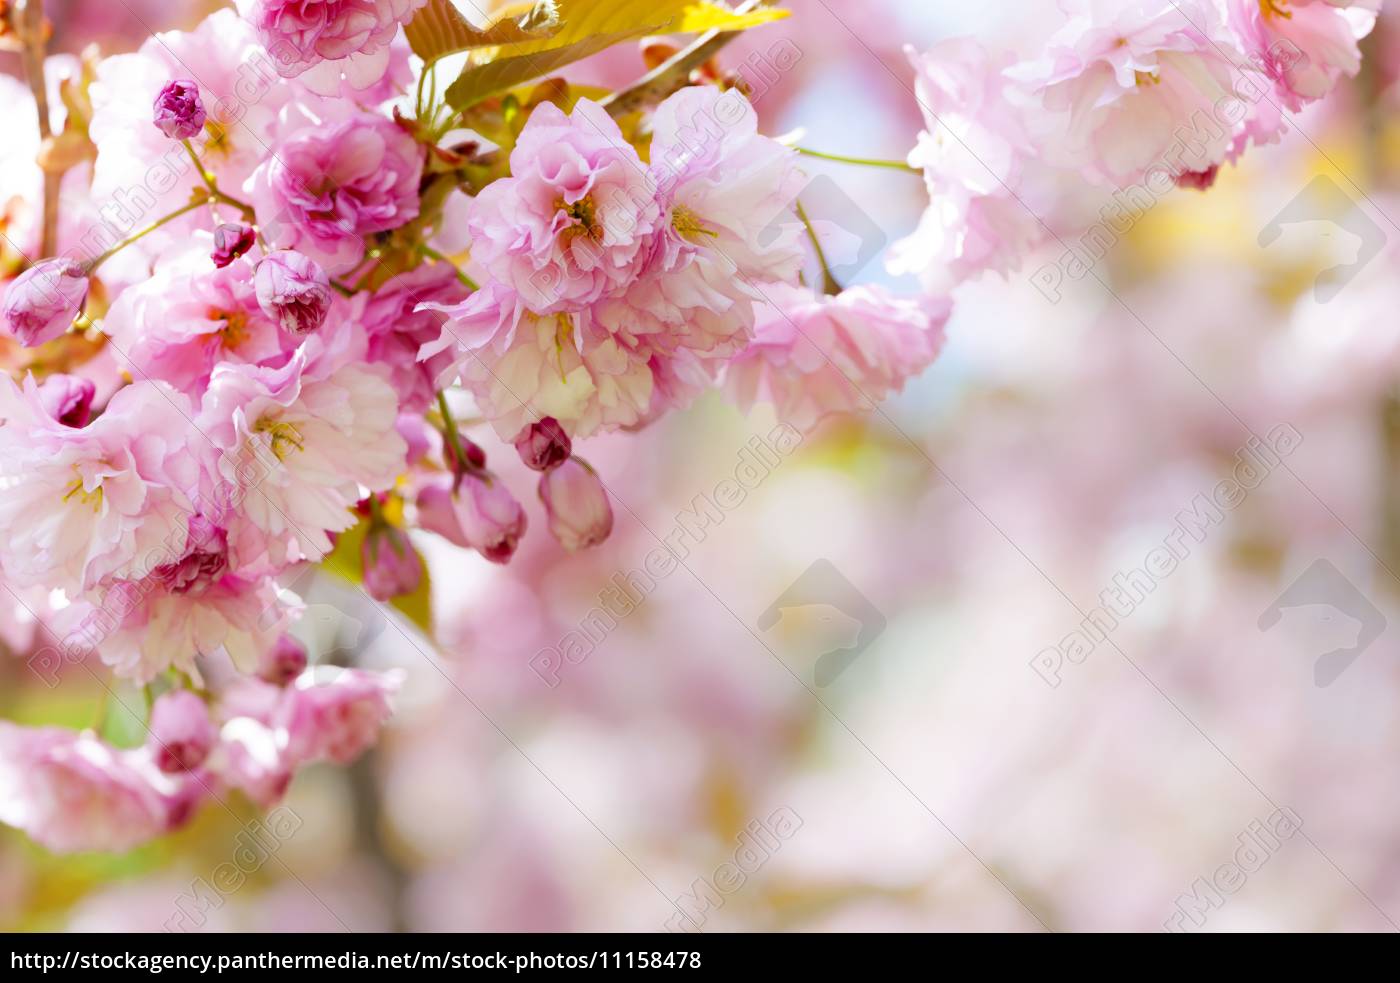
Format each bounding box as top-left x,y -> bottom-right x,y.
0,0 -> 1375,850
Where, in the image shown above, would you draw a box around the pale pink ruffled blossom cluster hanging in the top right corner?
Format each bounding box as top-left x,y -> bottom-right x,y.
889,0 -> 1380,288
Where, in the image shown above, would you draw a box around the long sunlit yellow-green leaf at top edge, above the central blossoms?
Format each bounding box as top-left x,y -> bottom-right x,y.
447,0 -> 788,109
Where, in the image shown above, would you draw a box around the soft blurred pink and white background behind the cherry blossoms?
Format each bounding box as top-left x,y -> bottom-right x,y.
0,0 -> 1400,931
